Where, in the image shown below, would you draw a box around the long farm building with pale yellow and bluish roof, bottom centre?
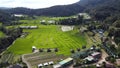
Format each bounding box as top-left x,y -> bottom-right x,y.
53,58 -> 73,68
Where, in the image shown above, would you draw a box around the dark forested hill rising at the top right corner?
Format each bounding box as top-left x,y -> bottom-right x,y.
77,0 -> 120,22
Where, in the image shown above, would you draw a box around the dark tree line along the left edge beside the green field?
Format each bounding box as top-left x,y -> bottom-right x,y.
0,26 -> 22,53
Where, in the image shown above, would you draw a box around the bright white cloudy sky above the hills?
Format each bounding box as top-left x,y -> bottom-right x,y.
0,0 -> 79,9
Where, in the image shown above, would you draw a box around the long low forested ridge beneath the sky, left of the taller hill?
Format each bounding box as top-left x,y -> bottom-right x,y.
5,4 -> 84,16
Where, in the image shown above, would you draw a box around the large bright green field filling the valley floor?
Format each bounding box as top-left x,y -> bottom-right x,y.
7,25 -> 87,55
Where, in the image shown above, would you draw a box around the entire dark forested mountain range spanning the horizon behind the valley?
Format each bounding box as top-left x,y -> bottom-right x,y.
2,0 -> 120,22
